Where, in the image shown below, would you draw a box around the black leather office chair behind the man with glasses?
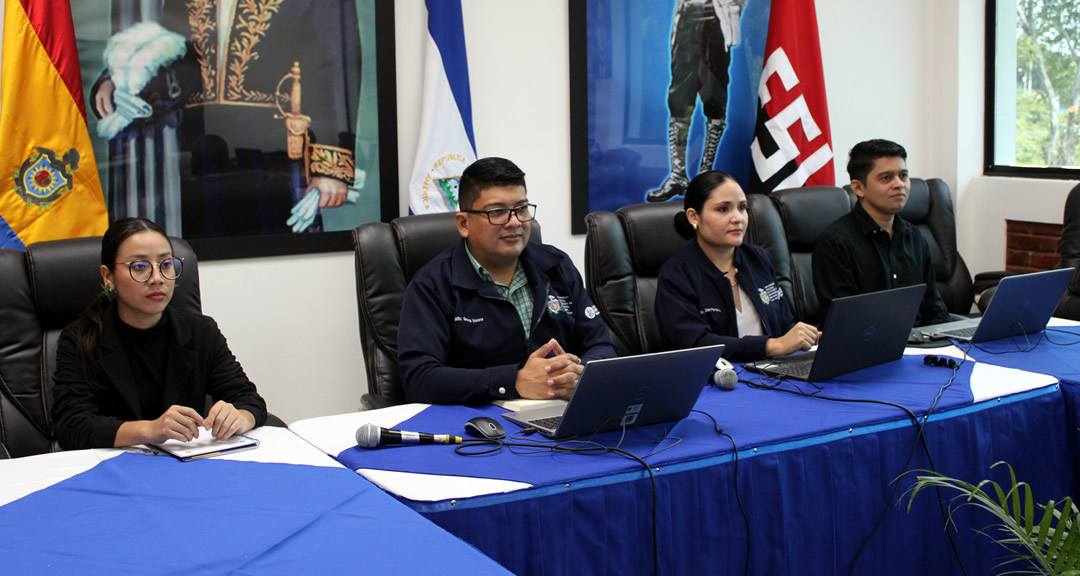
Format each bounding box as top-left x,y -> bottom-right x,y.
352,213 -> 541,410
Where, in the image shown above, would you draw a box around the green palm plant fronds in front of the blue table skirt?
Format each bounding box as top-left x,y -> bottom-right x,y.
907,461 -> 1080,576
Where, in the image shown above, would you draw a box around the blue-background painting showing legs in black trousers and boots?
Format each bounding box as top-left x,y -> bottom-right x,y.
570,0 -> 770,233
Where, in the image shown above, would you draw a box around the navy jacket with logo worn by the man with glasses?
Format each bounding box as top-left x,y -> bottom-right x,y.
397,240 -> 616,404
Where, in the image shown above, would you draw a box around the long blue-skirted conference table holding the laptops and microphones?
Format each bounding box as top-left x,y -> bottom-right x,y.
289,341 -> 1080,575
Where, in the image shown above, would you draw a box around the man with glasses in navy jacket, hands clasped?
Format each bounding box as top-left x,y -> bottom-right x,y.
397,158 -> 616,404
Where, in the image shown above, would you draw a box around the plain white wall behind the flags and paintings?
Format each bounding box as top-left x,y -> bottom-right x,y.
201,0 -> 1071,421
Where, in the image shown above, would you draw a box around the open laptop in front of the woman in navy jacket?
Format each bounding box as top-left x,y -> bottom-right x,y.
743,284 -> 927,381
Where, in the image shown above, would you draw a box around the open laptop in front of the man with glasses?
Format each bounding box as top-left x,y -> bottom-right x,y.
502,344 -> 724,438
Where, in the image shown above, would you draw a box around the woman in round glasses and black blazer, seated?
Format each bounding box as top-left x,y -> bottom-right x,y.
52,218 -> 267,450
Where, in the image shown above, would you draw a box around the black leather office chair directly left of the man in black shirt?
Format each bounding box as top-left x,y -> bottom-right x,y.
768,186 -> 851,325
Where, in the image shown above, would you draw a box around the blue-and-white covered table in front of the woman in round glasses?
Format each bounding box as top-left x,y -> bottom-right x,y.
0,427 -> 508,576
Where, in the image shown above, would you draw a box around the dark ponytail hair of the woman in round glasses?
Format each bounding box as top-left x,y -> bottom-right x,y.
68,218 -> 173,388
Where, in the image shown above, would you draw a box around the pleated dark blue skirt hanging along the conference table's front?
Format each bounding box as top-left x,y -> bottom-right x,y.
409,387 -> 1071,576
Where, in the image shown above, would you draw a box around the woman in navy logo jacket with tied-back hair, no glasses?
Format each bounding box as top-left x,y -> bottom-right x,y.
656,171 -> 821,362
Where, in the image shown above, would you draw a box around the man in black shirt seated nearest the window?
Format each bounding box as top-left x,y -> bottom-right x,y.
813,139 -> 949,326
